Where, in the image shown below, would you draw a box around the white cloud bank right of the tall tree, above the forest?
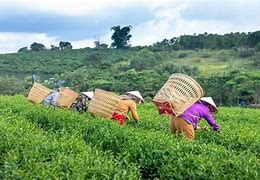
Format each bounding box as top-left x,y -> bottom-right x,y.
131,18 -> 260,46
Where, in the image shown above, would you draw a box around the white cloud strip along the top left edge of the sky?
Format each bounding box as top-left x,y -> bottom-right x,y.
0,0 -> 175,16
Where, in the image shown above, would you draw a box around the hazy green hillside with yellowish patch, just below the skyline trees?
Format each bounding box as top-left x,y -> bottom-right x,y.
0,48 -> 258,75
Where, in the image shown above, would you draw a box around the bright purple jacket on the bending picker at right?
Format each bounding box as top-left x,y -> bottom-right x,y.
181,102 -> 220,131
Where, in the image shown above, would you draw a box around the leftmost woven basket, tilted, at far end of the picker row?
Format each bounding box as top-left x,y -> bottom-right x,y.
27,83 -> 51,104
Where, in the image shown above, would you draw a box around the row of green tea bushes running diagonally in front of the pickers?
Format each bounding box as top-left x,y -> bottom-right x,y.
0,97 -> 260,179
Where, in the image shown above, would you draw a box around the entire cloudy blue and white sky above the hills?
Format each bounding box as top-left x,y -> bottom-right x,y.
0,0 -> 260,53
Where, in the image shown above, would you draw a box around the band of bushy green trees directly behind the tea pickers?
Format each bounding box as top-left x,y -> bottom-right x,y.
0,67 -> 260,105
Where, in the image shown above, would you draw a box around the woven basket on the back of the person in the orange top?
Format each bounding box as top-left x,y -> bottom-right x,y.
88,89 -> 122,118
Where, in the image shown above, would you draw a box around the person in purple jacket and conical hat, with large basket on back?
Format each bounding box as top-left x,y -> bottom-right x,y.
153,73 -> 220,140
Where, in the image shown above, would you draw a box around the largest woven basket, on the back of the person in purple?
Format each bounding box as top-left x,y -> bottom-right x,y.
153,73 -> 203,116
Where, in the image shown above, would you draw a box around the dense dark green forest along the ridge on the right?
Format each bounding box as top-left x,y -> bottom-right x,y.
152,31 -> 260,50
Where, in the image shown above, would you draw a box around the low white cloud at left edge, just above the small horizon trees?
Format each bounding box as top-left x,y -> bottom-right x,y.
0,32 -> 58,53
